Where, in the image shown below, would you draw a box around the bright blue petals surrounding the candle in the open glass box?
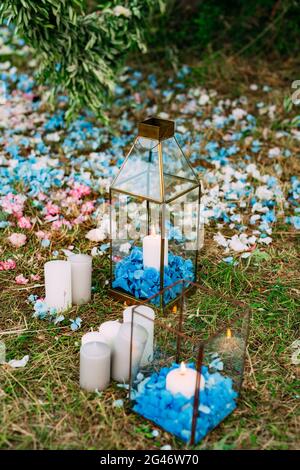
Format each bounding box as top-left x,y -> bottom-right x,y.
132,363 -> 238,443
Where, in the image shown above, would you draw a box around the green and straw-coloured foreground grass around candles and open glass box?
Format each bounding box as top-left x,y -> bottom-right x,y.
0,237 -> 299,449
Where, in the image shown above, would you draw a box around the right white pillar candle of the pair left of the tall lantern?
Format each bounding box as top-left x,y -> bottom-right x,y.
68,254 -> 92,305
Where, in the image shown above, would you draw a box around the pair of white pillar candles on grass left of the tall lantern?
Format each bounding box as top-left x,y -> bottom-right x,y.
44,254 -> 92,312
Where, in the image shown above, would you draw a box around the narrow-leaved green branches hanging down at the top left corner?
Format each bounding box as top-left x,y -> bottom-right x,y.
0,0 -> 157,119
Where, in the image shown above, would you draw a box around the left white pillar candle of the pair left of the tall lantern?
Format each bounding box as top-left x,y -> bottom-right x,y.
44,260 -> 72,312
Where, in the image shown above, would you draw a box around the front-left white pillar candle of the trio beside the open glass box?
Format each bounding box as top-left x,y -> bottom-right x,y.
80,341 -> 111,392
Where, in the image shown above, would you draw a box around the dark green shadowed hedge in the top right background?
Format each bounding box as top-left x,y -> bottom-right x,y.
149,0 -> 300,59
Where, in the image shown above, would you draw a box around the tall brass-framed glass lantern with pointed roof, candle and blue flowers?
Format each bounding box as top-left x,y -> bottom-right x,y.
110,117 -> 202,308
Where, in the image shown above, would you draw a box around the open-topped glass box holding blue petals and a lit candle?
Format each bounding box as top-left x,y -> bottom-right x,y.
123,281 -> 250,445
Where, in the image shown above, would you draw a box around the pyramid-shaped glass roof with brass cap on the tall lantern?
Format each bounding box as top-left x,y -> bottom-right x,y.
111,117 -> 200,203
